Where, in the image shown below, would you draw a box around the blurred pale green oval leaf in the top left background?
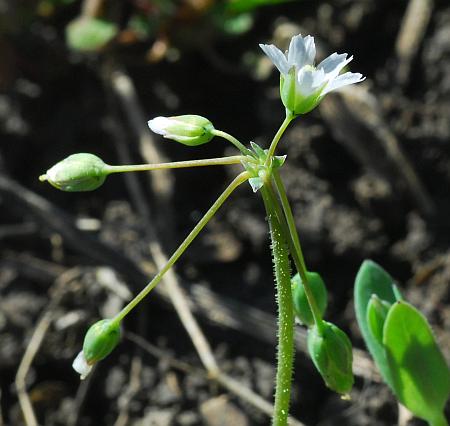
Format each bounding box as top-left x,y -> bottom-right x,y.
66,17 -> 118,52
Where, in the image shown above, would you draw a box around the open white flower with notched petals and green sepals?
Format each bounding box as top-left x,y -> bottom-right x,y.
259,35 -> 365,115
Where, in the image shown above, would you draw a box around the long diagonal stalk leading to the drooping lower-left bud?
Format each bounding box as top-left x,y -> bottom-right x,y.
110,172 -> 249,323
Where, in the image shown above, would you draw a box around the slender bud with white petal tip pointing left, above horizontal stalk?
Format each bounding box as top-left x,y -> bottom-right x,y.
148,115 -> 214,146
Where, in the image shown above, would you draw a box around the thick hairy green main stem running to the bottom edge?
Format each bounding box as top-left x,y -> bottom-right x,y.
261,186 -> 294,426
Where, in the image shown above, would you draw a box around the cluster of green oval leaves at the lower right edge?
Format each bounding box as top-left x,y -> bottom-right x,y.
355,260 -> 450,426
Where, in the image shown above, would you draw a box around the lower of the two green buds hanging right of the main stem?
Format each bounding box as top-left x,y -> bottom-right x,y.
308,321 -> 354,395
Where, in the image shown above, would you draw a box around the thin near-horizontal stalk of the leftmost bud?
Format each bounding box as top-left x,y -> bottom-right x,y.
107,155 -> 243,173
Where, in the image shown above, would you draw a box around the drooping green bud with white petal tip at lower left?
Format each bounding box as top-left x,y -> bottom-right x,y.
72,319 -> 120,380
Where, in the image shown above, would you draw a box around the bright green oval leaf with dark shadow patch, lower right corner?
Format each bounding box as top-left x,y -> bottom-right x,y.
383,302 -> 450,424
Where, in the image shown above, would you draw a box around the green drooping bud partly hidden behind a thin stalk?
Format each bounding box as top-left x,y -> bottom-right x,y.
291,272 -> 328,326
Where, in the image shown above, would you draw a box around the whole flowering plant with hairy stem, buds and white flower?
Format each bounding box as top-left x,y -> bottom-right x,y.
40,35 -> 370,426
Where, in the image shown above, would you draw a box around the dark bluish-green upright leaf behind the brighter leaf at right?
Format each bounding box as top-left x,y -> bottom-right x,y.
355,260 -> 396,388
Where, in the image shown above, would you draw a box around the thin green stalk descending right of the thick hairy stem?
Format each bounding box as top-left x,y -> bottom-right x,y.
268,170 -> 324,334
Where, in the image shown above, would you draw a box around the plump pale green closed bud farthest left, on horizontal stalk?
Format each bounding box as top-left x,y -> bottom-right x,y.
39,153 -> 109,192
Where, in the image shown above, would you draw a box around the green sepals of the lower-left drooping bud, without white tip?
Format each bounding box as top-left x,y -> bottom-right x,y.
83,319 -> 120,365
